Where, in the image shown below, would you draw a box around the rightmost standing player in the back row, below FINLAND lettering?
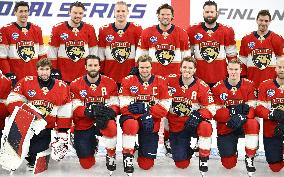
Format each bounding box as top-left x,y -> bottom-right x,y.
240,10 -> 284,86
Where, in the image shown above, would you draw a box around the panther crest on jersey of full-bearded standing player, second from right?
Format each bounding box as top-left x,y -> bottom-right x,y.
199,41 -> 220,63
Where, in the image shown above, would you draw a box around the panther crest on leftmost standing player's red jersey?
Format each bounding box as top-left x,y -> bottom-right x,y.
16,41 -> 35,62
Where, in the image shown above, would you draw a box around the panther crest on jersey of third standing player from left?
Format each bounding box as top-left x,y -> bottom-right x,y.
110,42 -> 131,63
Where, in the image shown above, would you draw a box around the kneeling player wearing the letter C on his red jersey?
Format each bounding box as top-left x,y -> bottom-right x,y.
119,55 -> 171,176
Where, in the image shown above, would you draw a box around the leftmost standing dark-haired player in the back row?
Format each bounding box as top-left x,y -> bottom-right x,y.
0,1 -> 45,86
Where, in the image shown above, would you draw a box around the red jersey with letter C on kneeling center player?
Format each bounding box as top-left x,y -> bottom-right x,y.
119,75 -> 171,132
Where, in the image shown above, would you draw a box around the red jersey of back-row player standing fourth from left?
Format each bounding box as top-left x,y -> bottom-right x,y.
136,25 -> 191,77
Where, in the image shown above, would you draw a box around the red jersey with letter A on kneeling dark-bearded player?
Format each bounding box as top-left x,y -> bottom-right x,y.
70,75 -> 119,130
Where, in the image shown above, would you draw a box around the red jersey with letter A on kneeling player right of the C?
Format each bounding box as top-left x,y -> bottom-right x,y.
167,75 -> 215,132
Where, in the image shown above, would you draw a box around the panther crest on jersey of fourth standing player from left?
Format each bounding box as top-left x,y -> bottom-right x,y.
155,44 -> 176,66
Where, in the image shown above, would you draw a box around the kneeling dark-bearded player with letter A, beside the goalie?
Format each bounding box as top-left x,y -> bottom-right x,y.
70,55 -> 119,174
